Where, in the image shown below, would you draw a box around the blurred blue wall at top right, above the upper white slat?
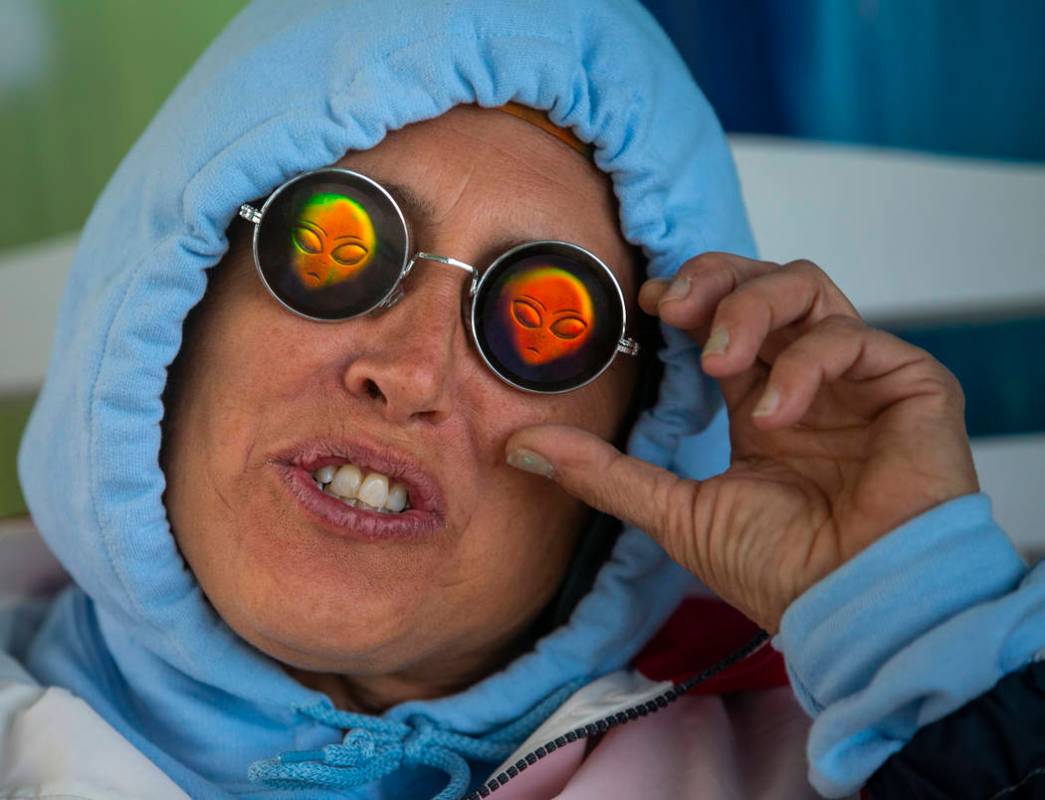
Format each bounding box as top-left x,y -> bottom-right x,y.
646,0 -> 1045,161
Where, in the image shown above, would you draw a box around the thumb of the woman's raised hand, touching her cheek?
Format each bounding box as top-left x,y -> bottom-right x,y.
505,425 -> 700,569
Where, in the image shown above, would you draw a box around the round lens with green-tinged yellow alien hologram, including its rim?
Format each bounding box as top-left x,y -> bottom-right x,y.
254,169 -> 410,320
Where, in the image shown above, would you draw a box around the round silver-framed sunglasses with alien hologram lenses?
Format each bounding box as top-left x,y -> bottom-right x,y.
239,167 -> 638,394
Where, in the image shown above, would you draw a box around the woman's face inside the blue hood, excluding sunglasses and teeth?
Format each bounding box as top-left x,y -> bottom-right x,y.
164,107 -> 636,705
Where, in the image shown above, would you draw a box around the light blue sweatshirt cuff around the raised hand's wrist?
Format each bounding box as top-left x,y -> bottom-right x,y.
773,494 -> 1026,715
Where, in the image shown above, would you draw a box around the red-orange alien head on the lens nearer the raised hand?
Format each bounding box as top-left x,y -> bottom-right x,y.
501,266 -> 596,367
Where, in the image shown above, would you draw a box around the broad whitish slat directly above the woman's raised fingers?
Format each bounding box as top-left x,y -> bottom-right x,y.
730,136 -> 1045,319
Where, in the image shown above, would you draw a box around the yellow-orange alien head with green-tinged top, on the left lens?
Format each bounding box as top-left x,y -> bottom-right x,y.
291,193 -> 375,289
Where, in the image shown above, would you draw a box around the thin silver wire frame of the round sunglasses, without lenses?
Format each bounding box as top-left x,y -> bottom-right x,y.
238,167 -> 640,395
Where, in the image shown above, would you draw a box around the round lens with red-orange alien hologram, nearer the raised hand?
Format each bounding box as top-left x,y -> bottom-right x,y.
471,241 -> 625,393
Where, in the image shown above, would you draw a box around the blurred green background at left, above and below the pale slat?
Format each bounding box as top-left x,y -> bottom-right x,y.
0,0 -> 246,518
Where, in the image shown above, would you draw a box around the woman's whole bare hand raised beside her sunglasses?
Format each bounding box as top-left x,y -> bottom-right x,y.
507,253 -> 978,632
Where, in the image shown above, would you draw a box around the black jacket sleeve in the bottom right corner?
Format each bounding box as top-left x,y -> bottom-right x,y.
863,661 -> 1045,800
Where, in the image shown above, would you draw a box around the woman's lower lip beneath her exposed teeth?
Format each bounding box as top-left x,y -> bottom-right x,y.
278,464 -> 443,541
